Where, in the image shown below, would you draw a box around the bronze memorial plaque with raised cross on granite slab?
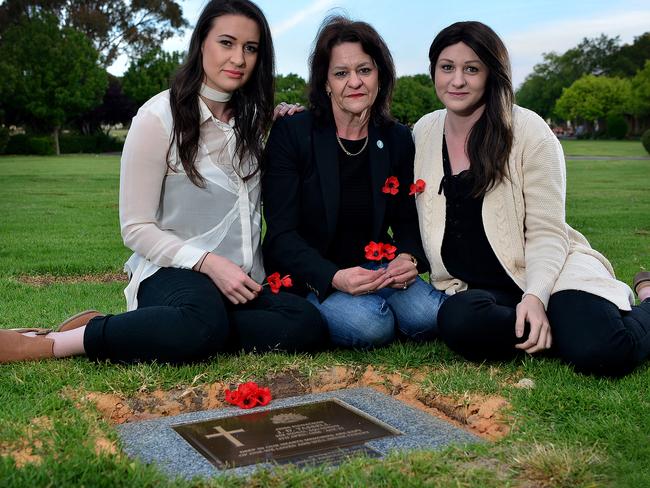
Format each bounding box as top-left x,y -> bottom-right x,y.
173,399 -> 401,468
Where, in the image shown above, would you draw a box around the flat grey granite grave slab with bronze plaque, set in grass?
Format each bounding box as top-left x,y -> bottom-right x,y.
118,388 -> 480,478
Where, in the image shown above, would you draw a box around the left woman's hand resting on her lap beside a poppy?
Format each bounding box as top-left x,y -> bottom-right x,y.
200,253 -> 262,305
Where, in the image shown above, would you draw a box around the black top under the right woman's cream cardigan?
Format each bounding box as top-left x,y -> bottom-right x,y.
439,135 -> 521,293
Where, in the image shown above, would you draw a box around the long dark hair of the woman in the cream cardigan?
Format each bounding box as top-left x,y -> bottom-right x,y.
429,21 -> 514,197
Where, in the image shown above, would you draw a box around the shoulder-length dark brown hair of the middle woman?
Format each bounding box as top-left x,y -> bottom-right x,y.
309,15 -> 395,125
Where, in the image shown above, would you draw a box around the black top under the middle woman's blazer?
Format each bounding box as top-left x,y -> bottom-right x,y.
325,139 -> 373,269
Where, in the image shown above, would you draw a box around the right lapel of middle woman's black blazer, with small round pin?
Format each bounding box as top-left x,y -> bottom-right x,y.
368,123 -> 388,236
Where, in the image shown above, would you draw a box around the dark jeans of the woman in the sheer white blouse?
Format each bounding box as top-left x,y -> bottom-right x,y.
84,268 -> 328,362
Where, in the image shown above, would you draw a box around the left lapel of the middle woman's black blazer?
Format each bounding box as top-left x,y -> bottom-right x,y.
313,122 -> 340,239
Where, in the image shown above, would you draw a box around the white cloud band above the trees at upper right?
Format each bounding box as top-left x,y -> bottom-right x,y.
503,10 -> 650,86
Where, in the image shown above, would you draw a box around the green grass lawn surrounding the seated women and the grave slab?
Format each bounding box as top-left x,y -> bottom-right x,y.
0,150 -> 650,487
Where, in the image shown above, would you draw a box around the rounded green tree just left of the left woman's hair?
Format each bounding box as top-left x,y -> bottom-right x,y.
122,48 -> 183,106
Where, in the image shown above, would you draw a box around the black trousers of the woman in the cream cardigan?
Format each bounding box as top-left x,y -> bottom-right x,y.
438,289 -> 650,376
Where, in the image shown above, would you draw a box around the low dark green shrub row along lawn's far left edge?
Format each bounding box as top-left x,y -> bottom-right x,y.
0,133 -> 124,156
